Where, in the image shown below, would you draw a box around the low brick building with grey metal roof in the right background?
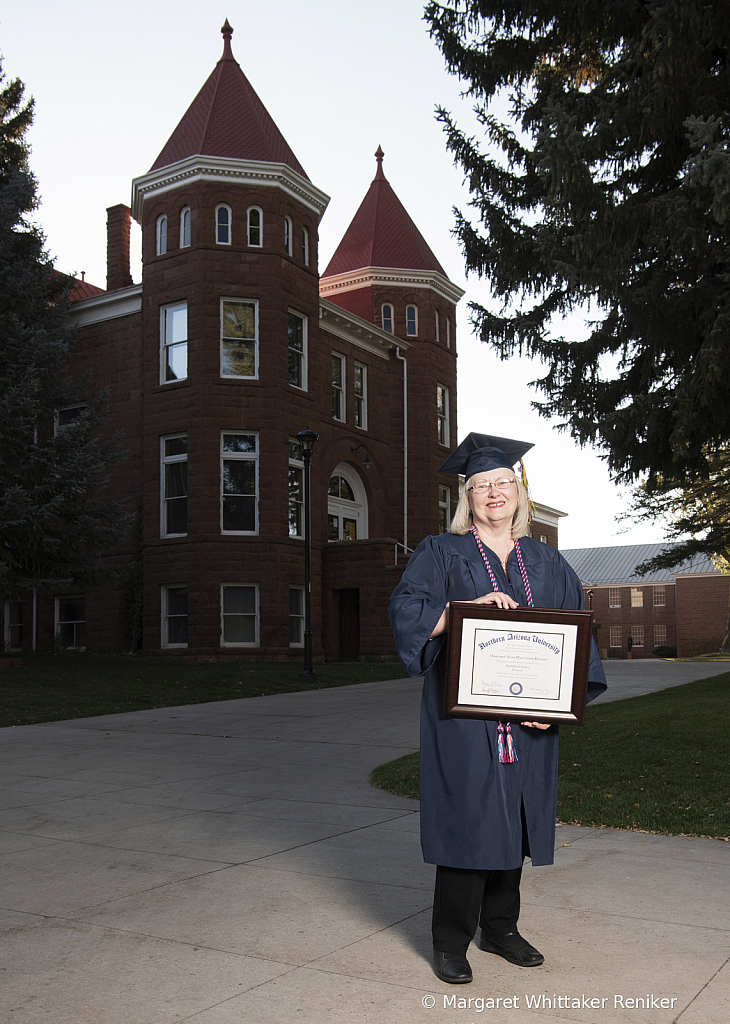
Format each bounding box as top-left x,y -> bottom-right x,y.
562,544 -> 730,657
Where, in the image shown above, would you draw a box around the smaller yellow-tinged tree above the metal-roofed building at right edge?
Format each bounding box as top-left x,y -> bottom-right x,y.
620,444 -> 730,651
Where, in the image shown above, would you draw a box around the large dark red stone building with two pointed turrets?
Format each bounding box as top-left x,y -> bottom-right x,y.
5,22 -> 463,659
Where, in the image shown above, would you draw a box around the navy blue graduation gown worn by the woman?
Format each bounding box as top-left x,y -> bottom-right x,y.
389,534 -> 606,870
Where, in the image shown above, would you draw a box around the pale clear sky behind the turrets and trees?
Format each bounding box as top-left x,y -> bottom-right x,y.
0,0 -> 663,548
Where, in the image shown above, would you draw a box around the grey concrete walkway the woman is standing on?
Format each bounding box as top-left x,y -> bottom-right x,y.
0,663 -> 730,1024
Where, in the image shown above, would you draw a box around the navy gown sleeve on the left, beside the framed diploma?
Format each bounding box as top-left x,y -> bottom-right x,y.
388,537 -> 447,676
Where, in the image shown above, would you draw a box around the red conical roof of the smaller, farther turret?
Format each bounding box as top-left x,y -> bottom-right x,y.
323,146 -> 446,278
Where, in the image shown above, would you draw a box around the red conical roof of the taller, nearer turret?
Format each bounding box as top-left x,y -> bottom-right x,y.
151,18 -> 308,180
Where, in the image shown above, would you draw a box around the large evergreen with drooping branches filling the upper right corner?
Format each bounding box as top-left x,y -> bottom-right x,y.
426,0 -> 730,486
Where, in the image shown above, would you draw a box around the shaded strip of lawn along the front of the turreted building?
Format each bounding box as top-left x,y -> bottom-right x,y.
0,654 -> 405,726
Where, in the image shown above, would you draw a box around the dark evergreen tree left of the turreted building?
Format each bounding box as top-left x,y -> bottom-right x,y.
0,59 -> 128,595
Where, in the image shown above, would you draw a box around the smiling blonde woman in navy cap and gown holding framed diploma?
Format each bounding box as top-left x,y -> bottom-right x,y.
390,433 -> 606,984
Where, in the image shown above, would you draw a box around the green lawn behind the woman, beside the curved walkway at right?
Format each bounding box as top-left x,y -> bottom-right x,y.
371,673 -> 730,839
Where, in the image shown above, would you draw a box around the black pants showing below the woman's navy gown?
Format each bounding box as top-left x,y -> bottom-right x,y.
431,865 -> 522,953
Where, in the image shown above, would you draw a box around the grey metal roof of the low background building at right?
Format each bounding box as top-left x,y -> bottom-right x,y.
560,544 -> 720,586
